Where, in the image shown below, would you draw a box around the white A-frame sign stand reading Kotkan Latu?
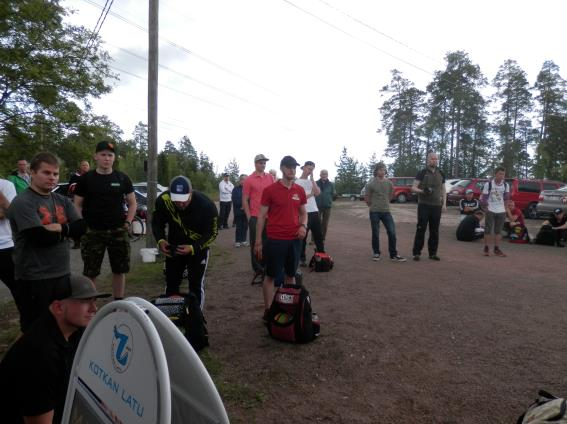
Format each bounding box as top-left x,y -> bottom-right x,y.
62,297 -> 229,424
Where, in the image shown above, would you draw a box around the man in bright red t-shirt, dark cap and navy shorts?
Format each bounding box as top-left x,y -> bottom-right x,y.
254,156 -> 307,317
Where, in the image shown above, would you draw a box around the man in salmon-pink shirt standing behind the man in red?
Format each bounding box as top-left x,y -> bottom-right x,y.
242,154 -> 275,284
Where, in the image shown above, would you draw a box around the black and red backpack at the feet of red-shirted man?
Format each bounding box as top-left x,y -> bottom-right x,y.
267,284 -> 320,343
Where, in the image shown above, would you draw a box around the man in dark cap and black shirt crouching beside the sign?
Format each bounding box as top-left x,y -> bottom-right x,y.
0,275 -> 110,424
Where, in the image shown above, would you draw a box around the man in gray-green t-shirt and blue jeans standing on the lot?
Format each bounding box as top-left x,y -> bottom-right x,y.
365,163 -> 406,262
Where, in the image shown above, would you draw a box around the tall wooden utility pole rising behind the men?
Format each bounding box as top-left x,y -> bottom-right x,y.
146,0 -> 159,247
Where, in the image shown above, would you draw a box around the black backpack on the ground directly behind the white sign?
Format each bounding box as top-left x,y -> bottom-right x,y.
150,293 -> 209,352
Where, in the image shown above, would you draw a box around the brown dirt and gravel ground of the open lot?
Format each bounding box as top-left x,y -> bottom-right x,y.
206,202 -> 567,424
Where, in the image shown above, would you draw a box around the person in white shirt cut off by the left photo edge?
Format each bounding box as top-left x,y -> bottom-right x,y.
0,179 -> 17,304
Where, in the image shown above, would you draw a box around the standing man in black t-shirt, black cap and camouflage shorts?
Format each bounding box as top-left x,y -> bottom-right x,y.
74,141 -> 136,299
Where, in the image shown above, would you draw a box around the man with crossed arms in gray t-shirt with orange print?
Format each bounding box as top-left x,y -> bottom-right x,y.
8,153 -> 85,332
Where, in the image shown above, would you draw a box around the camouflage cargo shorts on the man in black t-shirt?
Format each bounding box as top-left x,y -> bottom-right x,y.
81,227 -> 130,278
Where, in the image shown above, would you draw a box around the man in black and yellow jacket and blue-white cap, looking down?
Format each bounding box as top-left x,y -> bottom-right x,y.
152,175 -> 218,309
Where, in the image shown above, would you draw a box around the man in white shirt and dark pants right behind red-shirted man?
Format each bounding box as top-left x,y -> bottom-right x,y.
295,160 -> 325,266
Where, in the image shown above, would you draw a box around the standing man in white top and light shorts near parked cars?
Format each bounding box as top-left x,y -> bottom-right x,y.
480,166 -> 510,257
